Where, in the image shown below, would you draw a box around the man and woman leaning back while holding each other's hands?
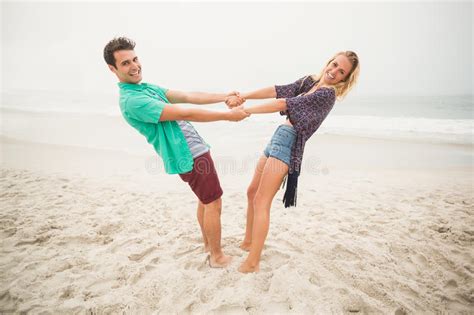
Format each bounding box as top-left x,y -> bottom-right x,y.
104,37 -> 360,273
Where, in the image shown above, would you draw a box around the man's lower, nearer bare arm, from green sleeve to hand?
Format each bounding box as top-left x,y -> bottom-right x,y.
160,105 -> 250,122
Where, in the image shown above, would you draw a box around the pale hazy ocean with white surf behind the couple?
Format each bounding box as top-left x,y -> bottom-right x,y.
0,90 -> 474,144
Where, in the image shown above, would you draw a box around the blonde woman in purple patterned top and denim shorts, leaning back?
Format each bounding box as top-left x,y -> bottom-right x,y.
226,51 -> 360,273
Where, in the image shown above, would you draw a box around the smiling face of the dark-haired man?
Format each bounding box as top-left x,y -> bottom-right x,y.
109,50 -> 142,84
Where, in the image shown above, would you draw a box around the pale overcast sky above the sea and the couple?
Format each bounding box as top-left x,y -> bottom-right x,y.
1,1 -> 474,96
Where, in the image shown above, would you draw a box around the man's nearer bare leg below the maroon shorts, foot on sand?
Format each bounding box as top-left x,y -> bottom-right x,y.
203,198 -> 232,268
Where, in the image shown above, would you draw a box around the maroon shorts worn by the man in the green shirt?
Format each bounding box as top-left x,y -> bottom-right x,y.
179,152 -> 222,204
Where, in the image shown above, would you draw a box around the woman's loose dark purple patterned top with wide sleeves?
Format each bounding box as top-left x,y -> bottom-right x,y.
275,76 -> 336,174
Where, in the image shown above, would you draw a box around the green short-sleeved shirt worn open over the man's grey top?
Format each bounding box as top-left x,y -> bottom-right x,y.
118,82 -> 194,174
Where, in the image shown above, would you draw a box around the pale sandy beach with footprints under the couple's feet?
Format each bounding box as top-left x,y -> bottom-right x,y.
0,108 -> 474,315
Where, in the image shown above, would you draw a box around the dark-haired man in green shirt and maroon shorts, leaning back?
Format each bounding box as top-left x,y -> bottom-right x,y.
104,37 -> 249,268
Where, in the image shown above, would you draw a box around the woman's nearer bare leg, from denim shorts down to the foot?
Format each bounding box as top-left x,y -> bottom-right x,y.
239,157 -> 288,273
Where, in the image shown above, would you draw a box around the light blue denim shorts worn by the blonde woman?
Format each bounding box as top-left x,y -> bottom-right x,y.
263,125 -> 296,166
